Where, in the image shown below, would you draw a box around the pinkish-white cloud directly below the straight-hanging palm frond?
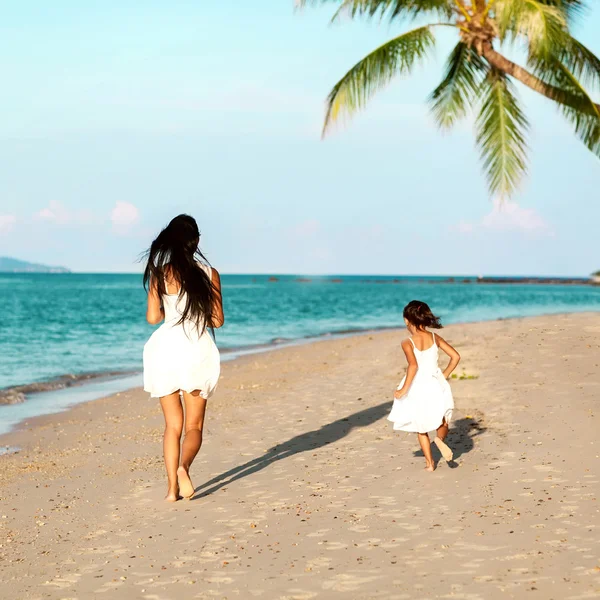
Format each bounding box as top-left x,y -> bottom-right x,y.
452,200 -> 554,236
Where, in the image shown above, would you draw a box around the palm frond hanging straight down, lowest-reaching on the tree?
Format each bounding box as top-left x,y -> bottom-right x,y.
475,69 -> 529,196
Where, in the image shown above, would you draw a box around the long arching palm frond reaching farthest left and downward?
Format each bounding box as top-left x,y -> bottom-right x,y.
323,26 -> 435,133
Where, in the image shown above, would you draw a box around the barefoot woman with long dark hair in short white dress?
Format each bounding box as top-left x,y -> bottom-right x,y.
144,215 -> 224,502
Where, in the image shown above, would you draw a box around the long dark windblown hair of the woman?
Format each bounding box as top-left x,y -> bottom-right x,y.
144,215 -> 216,333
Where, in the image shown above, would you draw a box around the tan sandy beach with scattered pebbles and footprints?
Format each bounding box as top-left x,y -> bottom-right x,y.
0,314 -> 600,600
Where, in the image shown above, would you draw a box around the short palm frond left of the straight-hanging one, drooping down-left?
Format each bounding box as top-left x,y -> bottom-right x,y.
429,42 -> 488,129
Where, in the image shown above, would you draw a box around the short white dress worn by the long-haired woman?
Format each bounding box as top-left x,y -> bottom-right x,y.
144,263 -> 221,398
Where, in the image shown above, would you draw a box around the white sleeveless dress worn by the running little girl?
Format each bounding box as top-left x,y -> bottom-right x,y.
388,333 -> 454,433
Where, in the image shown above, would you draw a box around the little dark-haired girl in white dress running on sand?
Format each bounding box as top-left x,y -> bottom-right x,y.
388,300 -> 460,471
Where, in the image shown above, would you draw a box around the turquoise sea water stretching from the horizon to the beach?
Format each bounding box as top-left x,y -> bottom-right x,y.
0,274 -> 600,436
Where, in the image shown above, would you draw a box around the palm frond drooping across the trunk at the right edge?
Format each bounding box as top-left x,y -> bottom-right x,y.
530,59 -> 600,157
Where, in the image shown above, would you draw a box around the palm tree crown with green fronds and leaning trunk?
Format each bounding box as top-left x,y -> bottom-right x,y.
297,0 -> 600,196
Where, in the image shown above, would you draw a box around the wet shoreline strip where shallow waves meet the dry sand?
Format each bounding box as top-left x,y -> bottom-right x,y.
0,311 -> 600,440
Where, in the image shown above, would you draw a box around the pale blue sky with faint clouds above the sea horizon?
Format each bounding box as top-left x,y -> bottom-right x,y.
0,0 -> 600,275
